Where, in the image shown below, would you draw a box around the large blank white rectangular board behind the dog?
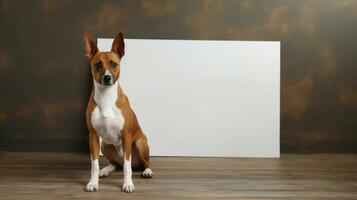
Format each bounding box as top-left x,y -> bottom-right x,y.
98,39 -> 280,157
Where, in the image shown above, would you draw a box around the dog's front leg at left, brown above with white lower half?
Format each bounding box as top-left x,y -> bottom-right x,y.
85,131 -> 99,192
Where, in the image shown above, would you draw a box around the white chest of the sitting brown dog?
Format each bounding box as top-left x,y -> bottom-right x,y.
91,80 -> 124,145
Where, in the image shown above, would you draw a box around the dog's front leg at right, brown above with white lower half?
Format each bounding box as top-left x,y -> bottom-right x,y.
121,132 -> 135,193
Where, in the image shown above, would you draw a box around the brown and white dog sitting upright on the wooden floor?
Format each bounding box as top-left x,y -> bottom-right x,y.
83,33 -> 153,192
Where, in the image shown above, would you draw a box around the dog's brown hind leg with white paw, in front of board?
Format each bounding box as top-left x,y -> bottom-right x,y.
135,135 -> 153,178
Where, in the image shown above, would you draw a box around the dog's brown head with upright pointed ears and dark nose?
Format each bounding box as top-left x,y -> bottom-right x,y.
83,32 -> 124,87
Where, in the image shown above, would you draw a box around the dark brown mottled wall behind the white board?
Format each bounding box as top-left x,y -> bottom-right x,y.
0,0 -> 357,153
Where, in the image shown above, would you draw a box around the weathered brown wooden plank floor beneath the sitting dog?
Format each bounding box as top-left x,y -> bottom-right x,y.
0,152 -> 357,200
